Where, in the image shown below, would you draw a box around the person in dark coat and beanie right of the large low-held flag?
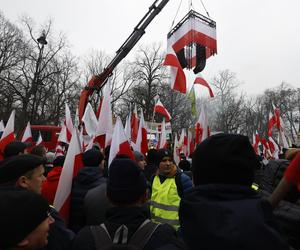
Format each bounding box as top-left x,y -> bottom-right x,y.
69,149 -> 105,232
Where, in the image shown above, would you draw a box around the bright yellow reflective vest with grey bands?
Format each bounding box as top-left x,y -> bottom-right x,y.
150,176 -> 180,229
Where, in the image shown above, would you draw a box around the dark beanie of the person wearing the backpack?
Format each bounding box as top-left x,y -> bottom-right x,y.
107,158 -> 147,205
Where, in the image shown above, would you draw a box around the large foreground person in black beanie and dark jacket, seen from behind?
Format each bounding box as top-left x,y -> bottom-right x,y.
179,133 -> 289,250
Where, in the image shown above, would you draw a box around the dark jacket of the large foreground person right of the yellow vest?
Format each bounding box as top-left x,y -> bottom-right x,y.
179,184 -> 288,250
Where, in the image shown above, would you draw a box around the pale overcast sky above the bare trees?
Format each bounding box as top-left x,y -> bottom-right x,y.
0,0 -> 300,94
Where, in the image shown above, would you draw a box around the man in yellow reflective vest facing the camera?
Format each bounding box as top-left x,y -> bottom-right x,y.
150,149 -> 192,229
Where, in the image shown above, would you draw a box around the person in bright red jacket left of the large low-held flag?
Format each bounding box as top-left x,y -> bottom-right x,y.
42,156 -> 65,204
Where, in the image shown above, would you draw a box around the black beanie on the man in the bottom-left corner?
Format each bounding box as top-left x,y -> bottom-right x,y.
0,188 -> 49,249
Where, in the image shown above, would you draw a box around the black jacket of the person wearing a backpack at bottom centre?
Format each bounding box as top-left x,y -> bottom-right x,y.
72,207 -> 185,250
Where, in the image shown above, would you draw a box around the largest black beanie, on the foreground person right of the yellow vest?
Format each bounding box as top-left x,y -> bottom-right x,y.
192,133 -> 259,186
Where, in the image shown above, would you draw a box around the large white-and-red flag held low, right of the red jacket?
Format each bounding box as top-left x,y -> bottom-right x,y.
53,128 -> 83,224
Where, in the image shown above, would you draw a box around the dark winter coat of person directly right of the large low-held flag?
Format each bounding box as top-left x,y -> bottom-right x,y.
69,167 -> 105,233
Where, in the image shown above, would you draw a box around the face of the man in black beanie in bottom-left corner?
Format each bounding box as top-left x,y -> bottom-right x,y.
26,212 -> 55,249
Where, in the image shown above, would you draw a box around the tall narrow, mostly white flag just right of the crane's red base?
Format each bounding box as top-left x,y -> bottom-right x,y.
95,84 -> 113,149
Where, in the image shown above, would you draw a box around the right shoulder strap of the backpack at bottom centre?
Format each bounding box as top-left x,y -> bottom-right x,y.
129,219 -> 159,249
